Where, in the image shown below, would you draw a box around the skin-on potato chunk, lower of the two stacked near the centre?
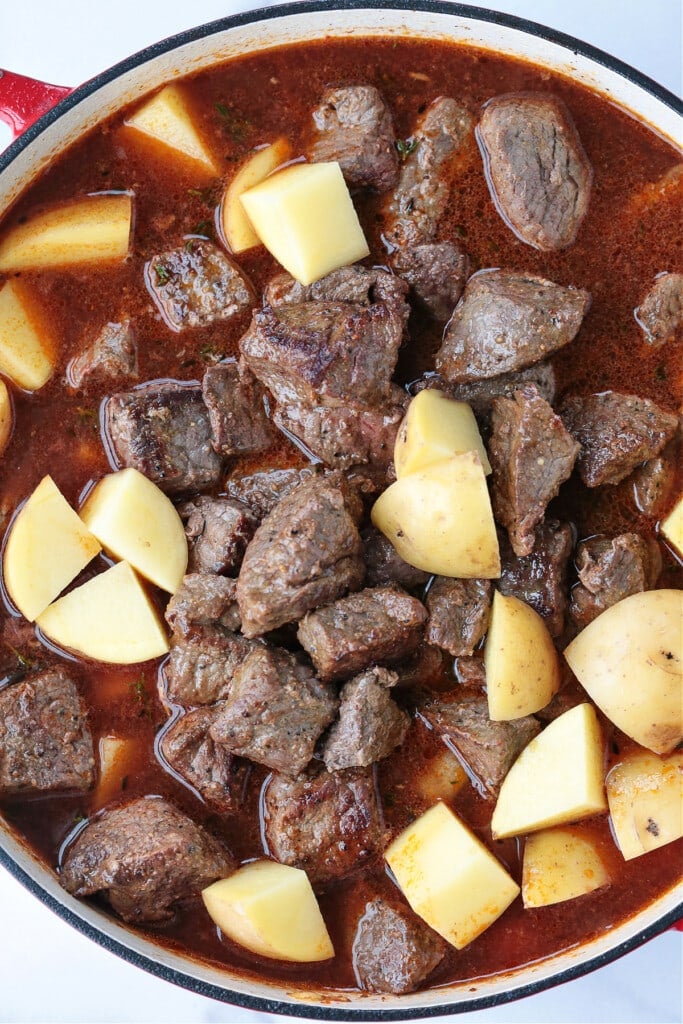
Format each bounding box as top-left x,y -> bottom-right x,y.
372,452 -> 501,580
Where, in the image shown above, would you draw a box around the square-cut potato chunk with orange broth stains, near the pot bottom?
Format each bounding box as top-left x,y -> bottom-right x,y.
385,804 -> 519,949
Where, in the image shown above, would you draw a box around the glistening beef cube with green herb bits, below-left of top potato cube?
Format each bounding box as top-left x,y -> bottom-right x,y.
145,241 -> 254,331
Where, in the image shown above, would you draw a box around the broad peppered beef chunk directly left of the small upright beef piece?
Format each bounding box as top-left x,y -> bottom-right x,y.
211,646 -> 337,775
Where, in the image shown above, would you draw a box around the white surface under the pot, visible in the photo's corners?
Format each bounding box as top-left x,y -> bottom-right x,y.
0,0 -> 683,1024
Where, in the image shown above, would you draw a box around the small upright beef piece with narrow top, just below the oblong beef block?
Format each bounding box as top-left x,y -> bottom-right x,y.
321,669 -> 411,771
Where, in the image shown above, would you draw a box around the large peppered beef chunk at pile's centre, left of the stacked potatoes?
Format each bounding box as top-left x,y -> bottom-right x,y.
238,477 -> 366,637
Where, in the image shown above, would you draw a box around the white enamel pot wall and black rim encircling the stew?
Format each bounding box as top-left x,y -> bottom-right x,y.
0,0 -> 683,1021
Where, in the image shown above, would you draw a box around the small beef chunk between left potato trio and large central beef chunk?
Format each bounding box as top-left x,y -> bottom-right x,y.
178,497 -> 258,574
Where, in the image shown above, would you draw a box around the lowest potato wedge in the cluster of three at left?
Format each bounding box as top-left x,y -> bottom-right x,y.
36,562 -> 168,665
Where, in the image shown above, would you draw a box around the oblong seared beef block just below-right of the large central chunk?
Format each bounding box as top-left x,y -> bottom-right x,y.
297,587 -> 427,680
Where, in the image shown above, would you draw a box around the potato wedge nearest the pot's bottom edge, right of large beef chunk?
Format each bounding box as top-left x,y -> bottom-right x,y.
202,860 -> 335,964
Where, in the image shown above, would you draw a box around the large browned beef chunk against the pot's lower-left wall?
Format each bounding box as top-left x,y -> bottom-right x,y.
59,797 -> 236,922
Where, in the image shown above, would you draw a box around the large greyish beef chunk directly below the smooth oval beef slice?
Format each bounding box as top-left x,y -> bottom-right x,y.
436,270 -> 591,384
